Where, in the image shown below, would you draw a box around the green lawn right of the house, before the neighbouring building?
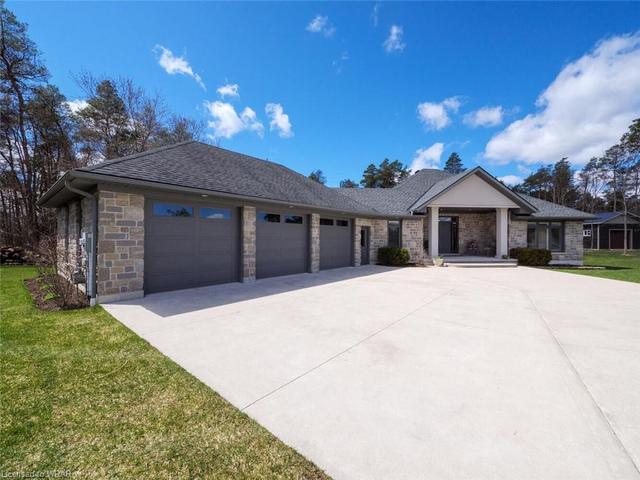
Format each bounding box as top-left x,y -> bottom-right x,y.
554,250 -> 640,283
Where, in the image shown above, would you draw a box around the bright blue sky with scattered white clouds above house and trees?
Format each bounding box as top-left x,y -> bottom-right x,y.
7,2 -> 640,185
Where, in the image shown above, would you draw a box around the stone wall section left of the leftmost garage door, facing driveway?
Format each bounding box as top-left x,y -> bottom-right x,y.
97,190 -> 144,302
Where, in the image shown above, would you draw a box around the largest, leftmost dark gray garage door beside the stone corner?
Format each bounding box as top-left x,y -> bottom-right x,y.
144,199 -> 239,293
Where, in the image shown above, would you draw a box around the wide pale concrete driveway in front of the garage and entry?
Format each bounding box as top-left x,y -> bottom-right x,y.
105,266 -> 640,480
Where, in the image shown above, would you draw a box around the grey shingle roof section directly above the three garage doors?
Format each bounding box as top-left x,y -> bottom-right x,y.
79,141 -> 379,215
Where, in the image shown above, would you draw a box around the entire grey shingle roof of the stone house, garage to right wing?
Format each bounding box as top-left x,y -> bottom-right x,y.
63,141 -> 591,219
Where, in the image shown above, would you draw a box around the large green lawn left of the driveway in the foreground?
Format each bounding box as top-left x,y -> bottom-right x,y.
0,267 -> 327,479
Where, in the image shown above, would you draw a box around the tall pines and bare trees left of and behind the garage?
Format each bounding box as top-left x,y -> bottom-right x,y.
0,2 -> 204,248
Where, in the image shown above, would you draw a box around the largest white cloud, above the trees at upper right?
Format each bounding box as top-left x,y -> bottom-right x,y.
484,32 -> 640,165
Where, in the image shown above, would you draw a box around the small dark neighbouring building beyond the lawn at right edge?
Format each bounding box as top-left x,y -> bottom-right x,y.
582,212 -> 640,250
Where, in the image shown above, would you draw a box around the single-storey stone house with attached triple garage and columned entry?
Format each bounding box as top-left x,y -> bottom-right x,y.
40,141 -> 589,302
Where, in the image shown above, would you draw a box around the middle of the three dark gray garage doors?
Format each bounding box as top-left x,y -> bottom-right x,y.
256,211 -> 309,278
